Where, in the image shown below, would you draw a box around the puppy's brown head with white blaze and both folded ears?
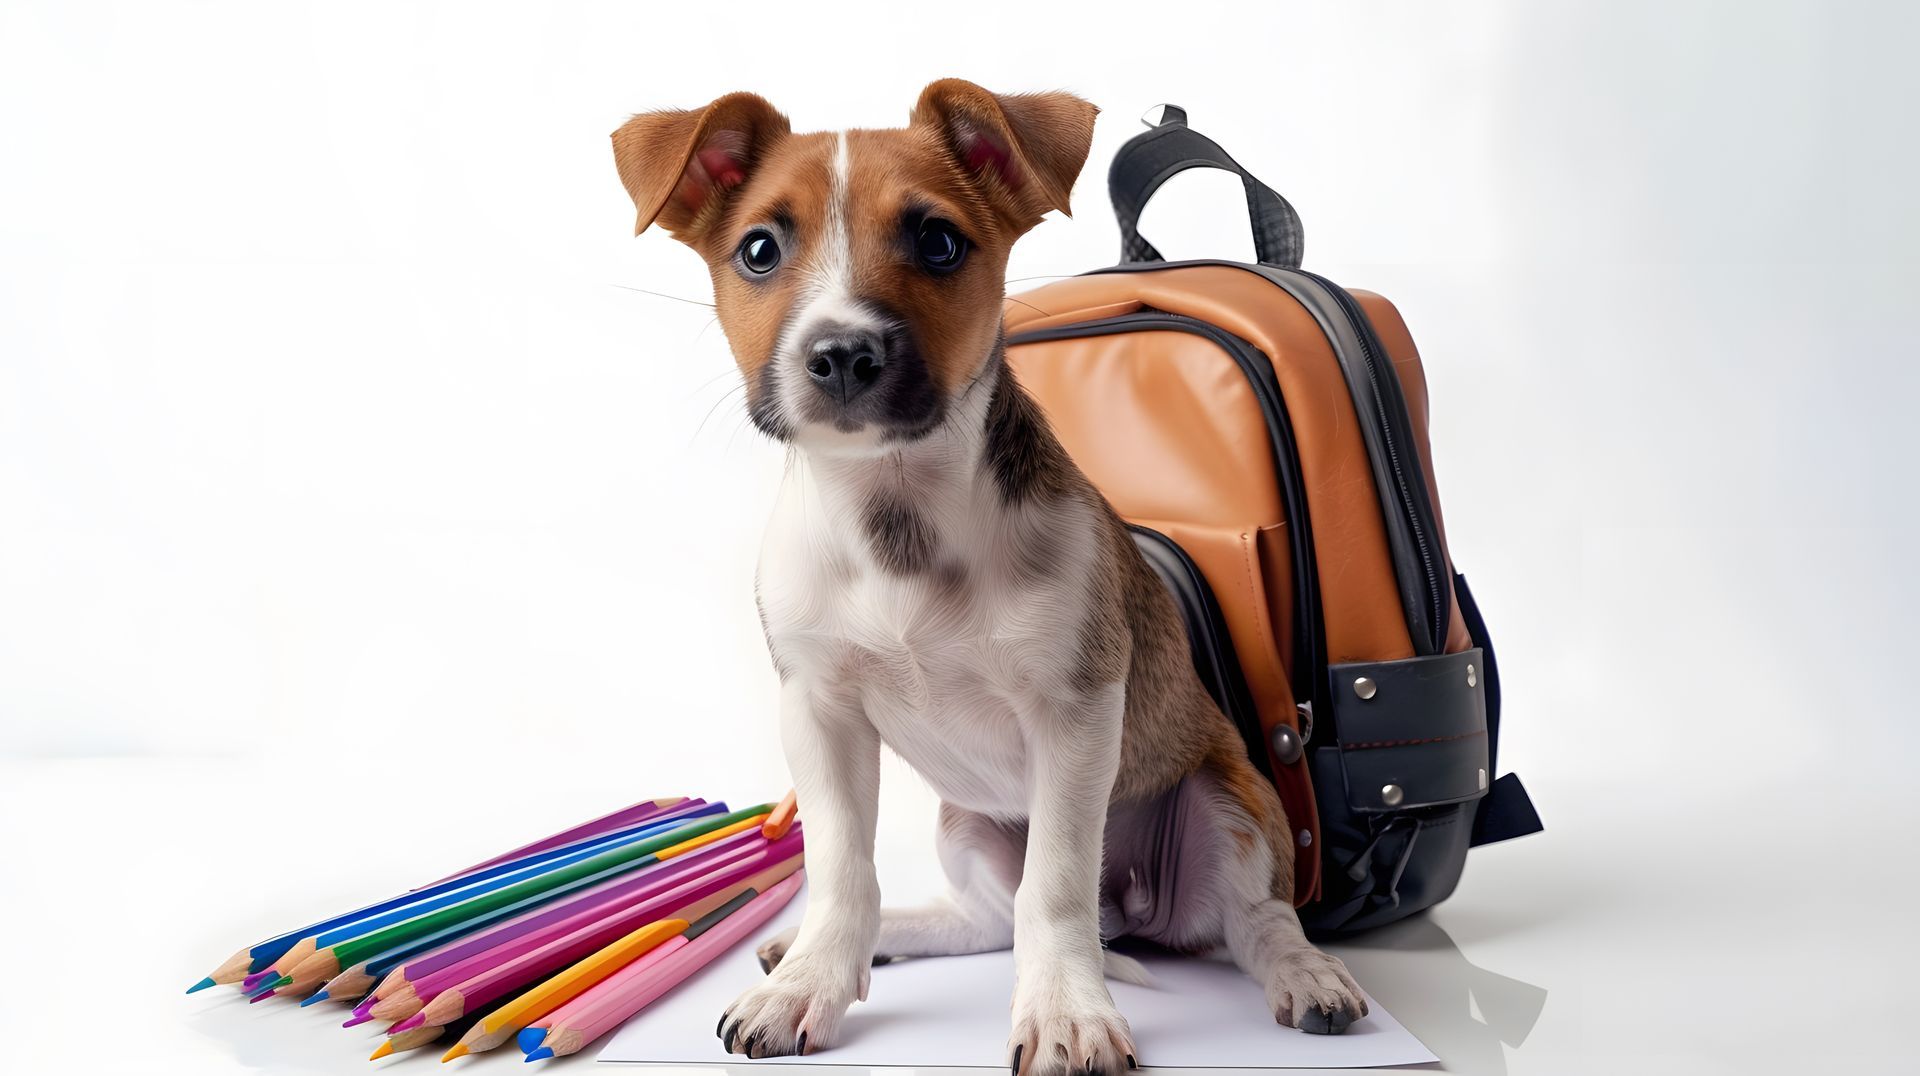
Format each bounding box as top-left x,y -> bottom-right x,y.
612,79 -> 1094,452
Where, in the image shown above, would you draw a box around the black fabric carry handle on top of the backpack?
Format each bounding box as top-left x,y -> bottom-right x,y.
1106,104 -> 1306,269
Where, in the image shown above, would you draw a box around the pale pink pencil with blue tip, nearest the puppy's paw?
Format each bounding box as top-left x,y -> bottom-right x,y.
520,870 -> 806,1061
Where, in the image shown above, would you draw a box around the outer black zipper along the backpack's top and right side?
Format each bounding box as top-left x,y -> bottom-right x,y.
1058,259 -> 1450,655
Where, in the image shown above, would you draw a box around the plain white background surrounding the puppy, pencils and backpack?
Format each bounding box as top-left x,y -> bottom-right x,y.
0,0 -> 1920,1072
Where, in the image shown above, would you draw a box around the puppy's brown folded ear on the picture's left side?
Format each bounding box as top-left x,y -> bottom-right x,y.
612,94 -> 791,242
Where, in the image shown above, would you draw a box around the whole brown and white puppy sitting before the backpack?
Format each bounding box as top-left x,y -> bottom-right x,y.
612,79 -> 1367,1076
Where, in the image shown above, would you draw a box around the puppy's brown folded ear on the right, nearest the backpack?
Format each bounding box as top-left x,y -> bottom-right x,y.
914,79 -> 1100,231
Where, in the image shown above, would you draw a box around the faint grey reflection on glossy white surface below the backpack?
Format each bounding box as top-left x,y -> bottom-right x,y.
1327,915 -> 1548,1072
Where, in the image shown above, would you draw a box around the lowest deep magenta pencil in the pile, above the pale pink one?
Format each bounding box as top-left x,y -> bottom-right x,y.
392,832 -> 801,1032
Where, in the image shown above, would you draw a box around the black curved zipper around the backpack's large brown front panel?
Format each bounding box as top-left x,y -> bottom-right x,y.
1006,311 -> 1327,722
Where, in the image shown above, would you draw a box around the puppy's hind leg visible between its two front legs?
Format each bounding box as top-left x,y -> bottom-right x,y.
758,803 -> 1027,972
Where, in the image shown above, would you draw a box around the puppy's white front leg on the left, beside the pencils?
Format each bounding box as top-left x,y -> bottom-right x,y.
718,680 -> 879,1057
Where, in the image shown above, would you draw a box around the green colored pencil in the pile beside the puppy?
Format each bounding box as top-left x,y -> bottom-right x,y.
288,803 -> 772,995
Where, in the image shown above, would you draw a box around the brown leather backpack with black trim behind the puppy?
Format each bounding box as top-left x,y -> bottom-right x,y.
1006,106 -> 1542,932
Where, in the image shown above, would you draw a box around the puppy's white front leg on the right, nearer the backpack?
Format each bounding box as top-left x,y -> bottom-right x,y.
1008,684 -> 1135,1076
